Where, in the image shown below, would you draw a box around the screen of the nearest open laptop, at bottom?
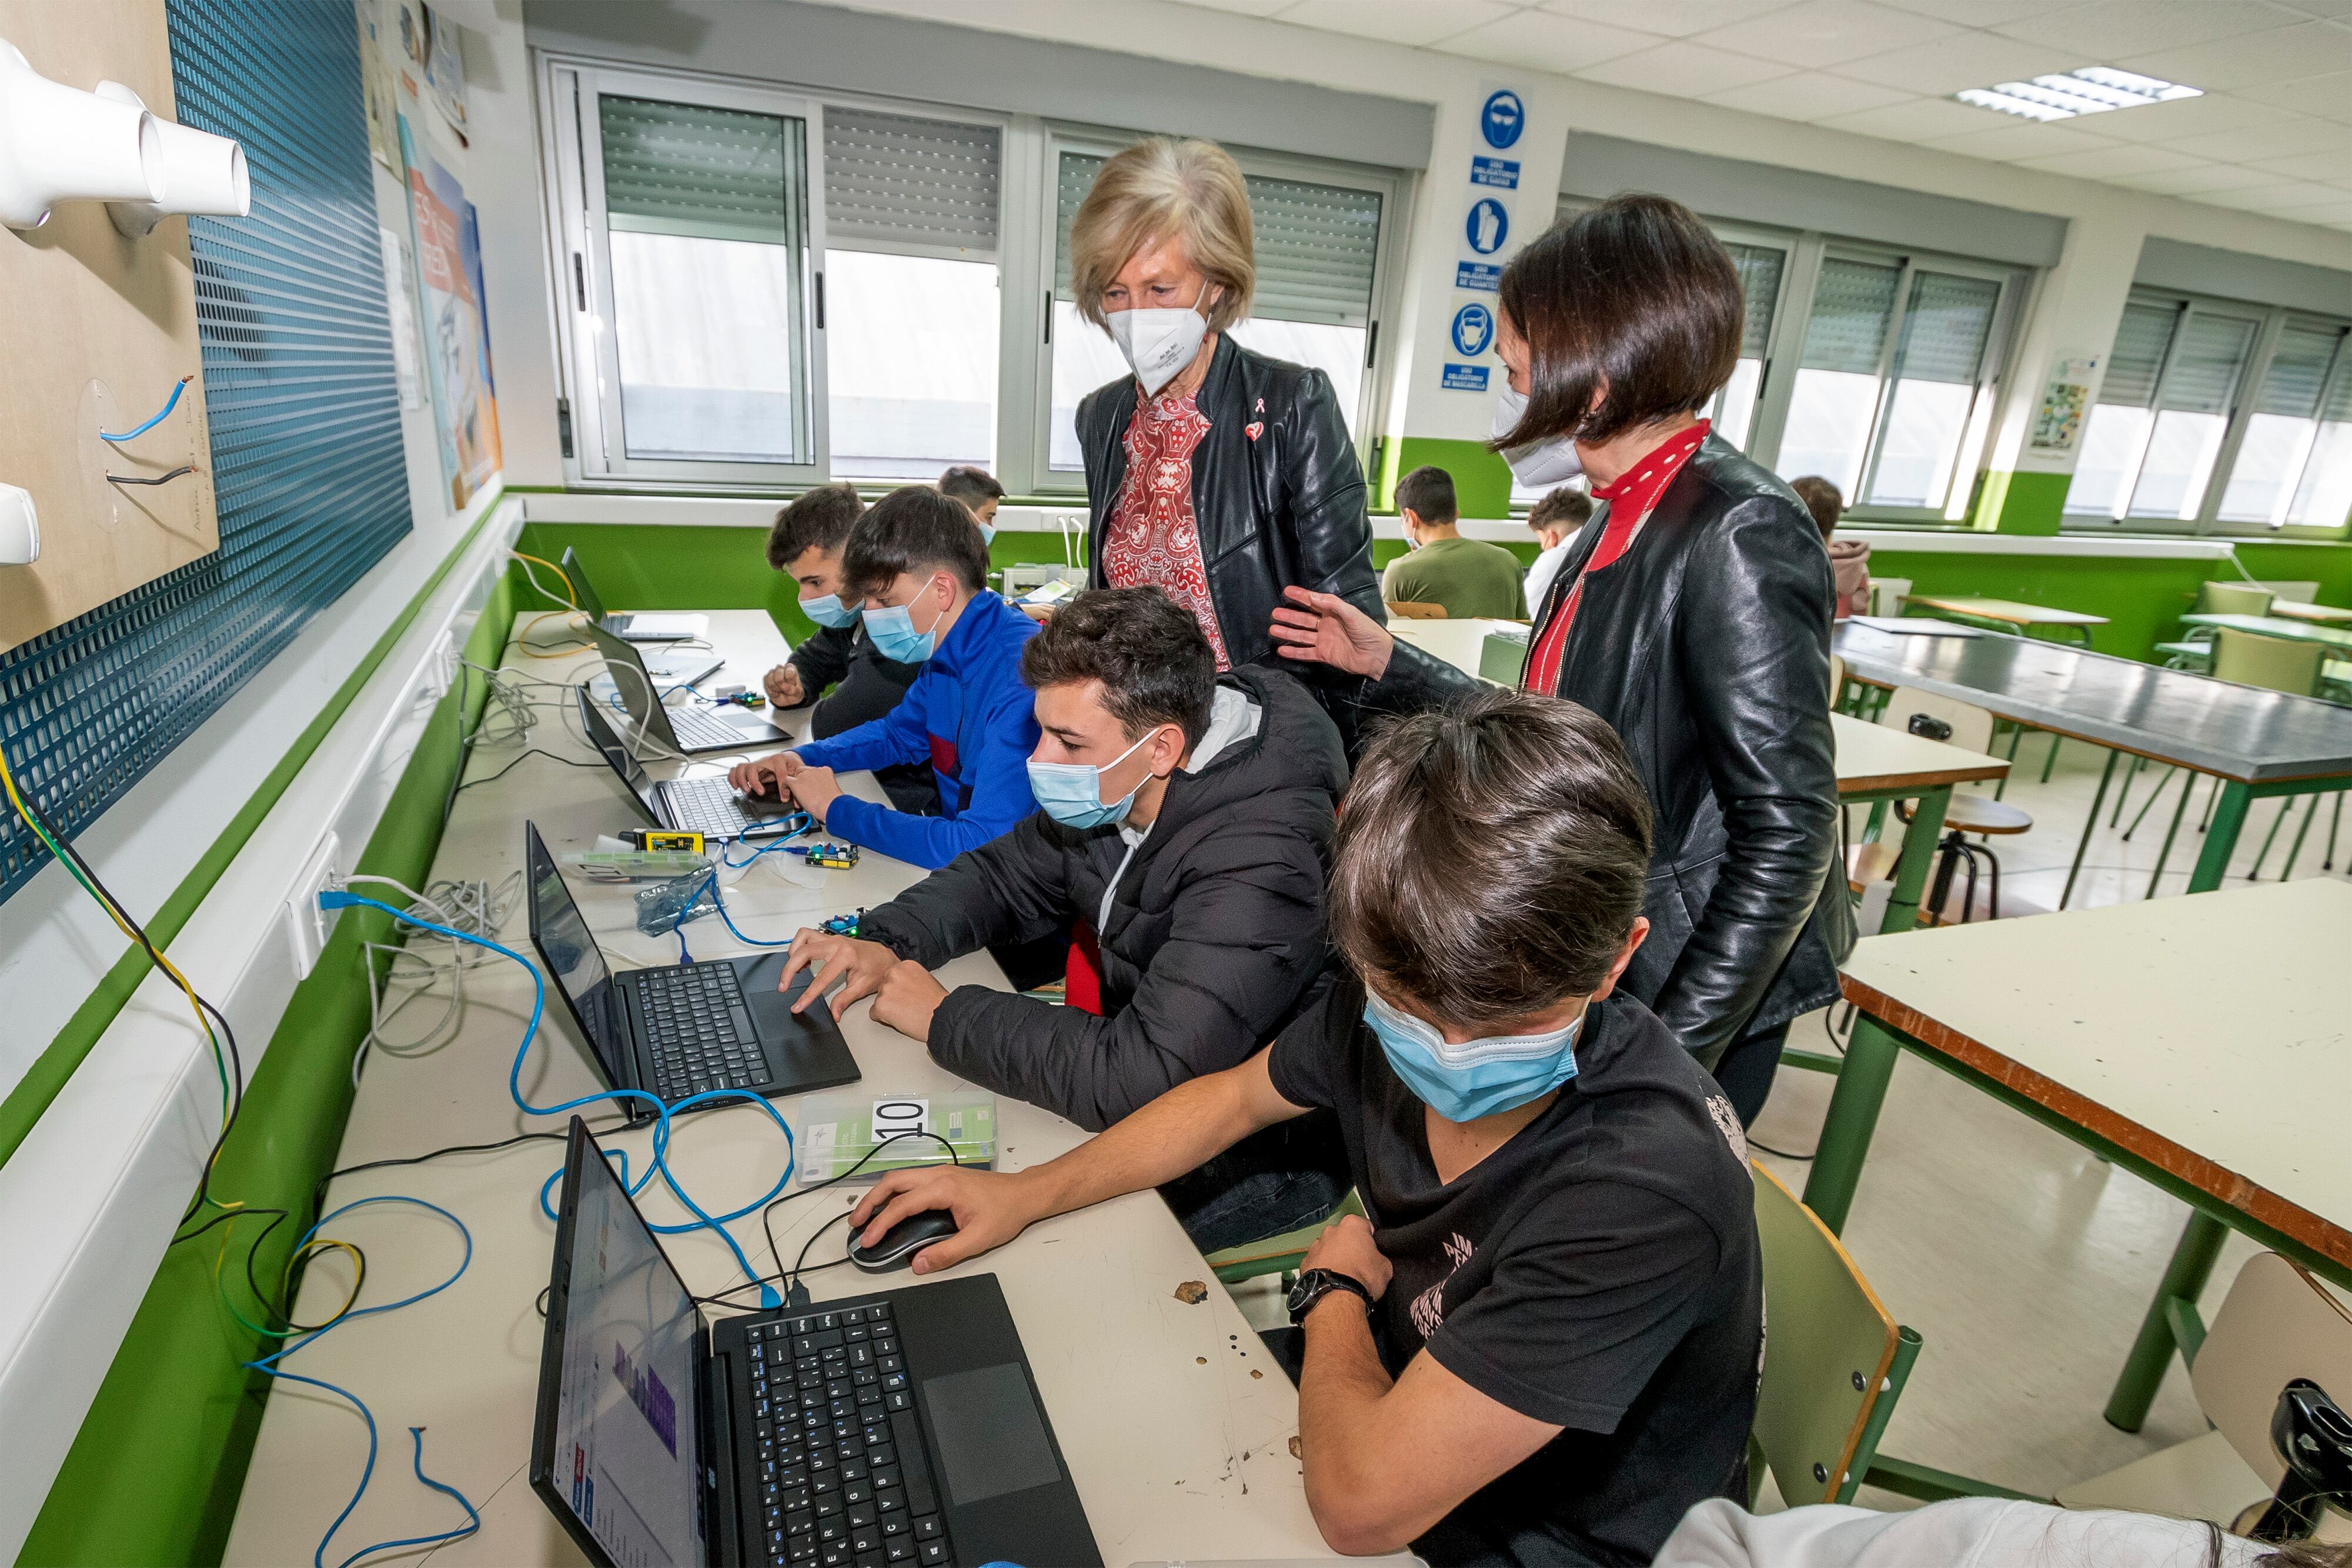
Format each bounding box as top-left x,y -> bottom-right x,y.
550,1138 -> 708,1568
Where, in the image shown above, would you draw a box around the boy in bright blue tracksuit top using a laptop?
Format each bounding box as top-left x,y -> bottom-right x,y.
727,484 -> 1037,870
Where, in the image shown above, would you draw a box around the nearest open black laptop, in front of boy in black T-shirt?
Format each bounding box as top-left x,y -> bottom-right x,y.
532,1116 -> 1103,1568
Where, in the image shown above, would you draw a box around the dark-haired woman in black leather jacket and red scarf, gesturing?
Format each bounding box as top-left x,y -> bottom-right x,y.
1275,195 -> 1853,1126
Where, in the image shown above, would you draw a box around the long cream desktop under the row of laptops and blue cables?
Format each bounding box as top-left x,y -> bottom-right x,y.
226,611 -> 1331,1566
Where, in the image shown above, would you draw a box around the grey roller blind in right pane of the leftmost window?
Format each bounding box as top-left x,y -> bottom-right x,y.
826,108 -> 1004,261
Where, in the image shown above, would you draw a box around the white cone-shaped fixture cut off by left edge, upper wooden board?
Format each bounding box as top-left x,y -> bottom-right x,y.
0,40 -> 165,228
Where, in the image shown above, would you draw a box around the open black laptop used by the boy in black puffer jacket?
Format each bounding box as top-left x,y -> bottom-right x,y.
522,823 -> 858,1121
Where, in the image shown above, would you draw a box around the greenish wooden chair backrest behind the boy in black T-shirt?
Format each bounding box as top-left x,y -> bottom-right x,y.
1748,1166 -> 1919,1507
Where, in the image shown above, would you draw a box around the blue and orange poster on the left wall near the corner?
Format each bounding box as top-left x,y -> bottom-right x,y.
400,115 -> 499,508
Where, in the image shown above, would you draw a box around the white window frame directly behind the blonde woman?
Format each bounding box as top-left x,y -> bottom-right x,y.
1025,120 -> 1414,506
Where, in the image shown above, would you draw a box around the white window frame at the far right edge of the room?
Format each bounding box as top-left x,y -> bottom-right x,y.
2058,285 -> 2352,539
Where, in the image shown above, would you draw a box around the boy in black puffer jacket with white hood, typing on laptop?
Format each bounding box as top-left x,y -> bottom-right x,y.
783,588 -> 1348,1253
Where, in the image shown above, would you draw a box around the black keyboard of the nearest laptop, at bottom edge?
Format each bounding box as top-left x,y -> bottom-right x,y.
746,1302 -> 955,1568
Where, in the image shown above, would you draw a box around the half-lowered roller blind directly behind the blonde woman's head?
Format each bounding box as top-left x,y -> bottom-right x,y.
1054,153 -> 1381,327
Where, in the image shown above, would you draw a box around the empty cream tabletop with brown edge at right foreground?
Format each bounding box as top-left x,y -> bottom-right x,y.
1844,877 -> 2352,1267
